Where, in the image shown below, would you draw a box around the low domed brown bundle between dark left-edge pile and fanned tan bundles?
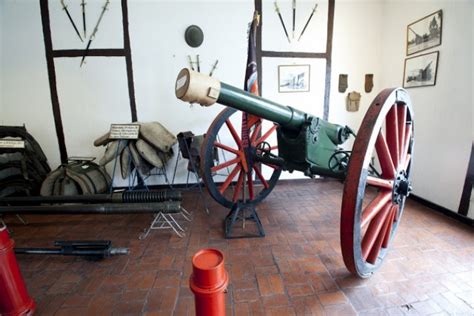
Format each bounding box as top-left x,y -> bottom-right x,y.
41,160 -> 112,196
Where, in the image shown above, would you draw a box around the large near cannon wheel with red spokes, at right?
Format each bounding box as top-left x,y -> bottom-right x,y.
340,88 -> 413,278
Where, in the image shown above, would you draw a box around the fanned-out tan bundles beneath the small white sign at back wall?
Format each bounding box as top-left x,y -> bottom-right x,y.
94,122 -> 177,179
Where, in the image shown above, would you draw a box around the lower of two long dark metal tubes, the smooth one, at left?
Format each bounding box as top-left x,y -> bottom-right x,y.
0,201 -> 181,215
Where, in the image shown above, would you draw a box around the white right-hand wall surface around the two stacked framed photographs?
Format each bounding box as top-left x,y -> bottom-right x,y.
381,0 -> 474,216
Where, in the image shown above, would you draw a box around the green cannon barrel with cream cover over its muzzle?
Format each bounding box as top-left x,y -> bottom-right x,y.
175,68 -> 307,130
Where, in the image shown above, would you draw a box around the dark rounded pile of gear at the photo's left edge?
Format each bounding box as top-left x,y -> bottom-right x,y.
0,126 -> 51,197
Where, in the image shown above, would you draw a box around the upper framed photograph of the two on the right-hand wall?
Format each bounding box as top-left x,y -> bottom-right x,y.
407,10 -> 443,55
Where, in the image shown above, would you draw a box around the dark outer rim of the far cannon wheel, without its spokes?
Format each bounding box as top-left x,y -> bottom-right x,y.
201,108 -> 281,208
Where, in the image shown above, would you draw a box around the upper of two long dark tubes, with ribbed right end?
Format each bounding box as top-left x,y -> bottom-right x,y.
0,190 -> 183,205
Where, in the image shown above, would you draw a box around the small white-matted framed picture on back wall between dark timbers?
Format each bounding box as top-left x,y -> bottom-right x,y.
278,65 -> 310,92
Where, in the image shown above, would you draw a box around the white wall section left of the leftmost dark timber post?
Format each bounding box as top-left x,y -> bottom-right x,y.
0,0 -> 60,166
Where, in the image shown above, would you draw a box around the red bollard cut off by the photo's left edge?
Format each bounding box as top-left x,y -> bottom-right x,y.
0,226 -> 35,316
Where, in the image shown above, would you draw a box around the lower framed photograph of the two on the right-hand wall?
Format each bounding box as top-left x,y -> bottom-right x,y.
403,51 -> 439,88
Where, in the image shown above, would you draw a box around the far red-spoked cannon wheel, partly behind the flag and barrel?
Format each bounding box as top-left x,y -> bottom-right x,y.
201,108 -> 281,208
